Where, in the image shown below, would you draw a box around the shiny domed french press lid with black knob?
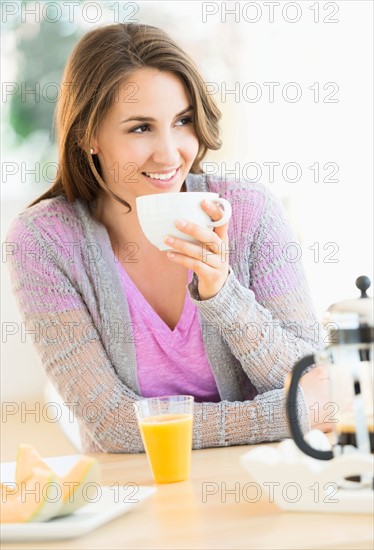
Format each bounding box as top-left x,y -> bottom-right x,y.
323,275 -> 374,347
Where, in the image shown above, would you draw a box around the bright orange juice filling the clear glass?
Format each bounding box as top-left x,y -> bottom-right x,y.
139,414 -> 193,483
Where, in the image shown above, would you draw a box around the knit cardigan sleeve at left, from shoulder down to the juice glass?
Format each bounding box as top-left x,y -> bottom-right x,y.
7,213 -> 144,453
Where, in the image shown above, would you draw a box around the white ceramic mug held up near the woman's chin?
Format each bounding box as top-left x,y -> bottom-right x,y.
136,191 -> 231,250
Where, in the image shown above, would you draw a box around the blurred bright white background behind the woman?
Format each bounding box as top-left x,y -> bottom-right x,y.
1,1 -> 373,401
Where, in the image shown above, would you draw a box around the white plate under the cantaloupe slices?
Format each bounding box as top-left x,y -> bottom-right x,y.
0,455 -> 156,542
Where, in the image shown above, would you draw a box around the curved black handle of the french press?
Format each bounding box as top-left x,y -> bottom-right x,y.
287,355 -> 333,460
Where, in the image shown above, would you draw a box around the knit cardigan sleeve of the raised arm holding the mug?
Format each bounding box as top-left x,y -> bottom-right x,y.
189,185 -> 321,394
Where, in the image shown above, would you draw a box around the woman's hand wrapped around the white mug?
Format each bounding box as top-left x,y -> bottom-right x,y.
165,201 -> 229,300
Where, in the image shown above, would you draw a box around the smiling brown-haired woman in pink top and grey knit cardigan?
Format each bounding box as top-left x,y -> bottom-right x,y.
7,24 -> 327,452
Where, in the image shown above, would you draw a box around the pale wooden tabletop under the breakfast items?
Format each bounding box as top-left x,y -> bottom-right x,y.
1,446 -> 373,550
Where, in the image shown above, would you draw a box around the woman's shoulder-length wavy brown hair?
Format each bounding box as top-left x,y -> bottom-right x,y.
29,23 -> 221,209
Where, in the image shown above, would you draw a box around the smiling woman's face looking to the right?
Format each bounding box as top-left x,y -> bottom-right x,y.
91,68 -> 199,204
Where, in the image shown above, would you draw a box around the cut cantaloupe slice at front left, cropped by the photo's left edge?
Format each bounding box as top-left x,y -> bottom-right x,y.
1,467 -> 63,523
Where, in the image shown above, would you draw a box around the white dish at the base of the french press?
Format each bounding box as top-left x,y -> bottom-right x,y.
240,438 -> 374,514
